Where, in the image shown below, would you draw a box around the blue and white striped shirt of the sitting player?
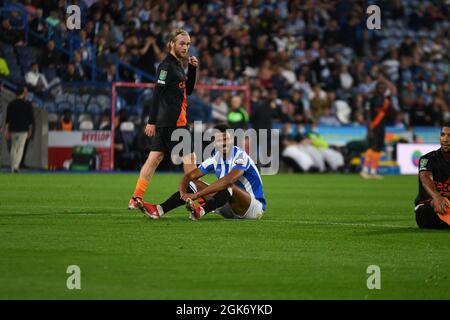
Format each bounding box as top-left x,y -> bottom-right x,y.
198,146 -> 266,210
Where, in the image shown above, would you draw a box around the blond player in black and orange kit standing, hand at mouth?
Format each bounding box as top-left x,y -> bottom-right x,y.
128,29 -> 198,213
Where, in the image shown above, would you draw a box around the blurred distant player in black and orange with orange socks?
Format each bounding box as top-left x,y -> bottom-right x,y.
360,82 -> 391,179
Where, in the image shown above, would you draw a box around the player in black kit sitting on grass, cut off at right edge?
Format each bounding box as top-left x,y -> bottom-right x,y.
415,122 -> 450,229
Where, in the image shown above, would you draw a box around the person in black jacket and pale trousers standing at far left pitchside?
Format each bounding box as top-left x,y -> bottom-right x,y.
5,87 -> 34,173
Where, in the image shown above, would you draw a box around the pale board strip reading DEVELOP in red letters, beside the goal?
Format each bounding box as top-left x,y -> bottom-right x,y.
48,131 -> 112,148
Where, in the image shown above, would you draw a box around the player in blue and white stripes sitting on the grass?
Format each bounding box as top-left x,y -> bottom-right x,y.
135,124 -> 266,220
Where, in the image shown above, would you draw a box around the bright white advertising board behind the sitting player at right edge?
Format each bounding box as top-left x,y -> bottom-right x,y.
397,143 -> 441,174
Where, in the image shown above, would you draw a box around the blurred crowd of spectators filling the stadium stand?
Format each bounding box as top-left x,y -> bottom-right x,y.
0,0 -> 450,132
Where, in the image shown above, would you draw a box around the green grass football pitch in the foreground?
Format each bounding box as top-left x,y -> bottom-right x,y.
0,174 -> 450,299
